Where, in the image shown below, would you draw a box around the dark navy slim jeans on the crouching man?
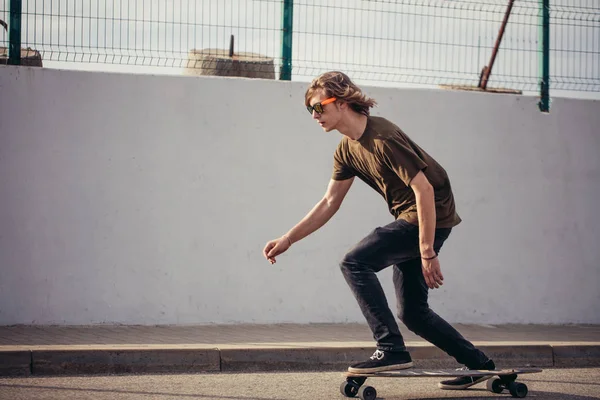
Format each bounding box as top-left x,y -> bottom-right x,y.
340,219 -> 488,369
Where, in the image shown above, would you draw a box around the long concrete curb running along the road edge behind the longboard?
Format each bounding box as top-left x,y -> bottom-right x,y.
0,344 -> 600,376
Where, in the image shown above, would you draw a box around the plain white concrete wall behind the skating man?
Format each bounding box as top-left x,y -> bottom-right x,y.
0,67 -> 600,324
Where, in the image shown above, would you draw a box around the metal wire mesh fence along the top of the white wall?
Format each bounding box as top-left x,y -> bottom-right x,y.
0,0 -> 600,97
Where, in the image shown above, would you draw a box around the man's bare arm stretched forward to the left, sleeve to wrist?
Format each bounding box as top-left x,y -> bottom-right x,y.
285,178 -> 354,243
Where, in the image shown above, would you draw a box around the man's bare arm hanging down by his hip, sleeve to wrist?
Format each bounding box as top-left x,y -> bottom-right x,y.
410,171 -> 436,258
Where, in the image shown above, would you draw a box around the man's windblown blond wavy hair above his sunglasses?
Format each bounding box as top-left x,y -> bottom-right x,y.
304,71 -> 377,116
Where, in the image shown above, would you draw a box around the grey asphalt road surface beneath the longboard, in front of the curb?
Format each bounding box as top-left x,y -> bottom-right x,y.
0,368 -> 600,400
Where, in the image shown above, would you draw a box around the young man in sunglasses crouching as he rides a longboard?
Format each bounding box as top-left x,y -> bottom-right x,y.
263,71 -> 495,389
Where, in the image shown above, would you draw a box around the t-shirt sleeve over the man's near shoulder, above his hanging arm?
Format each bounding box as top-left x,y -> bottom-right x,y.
381,138 -> 427,186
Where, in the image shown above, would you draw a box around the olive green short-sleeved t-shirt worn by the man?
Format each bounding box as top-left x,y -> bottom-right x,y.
332,116 -> 461,228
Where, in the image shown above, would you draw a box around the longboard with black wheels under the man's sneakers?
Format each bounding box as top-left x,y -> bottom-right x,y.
340,368 -> 542,400
